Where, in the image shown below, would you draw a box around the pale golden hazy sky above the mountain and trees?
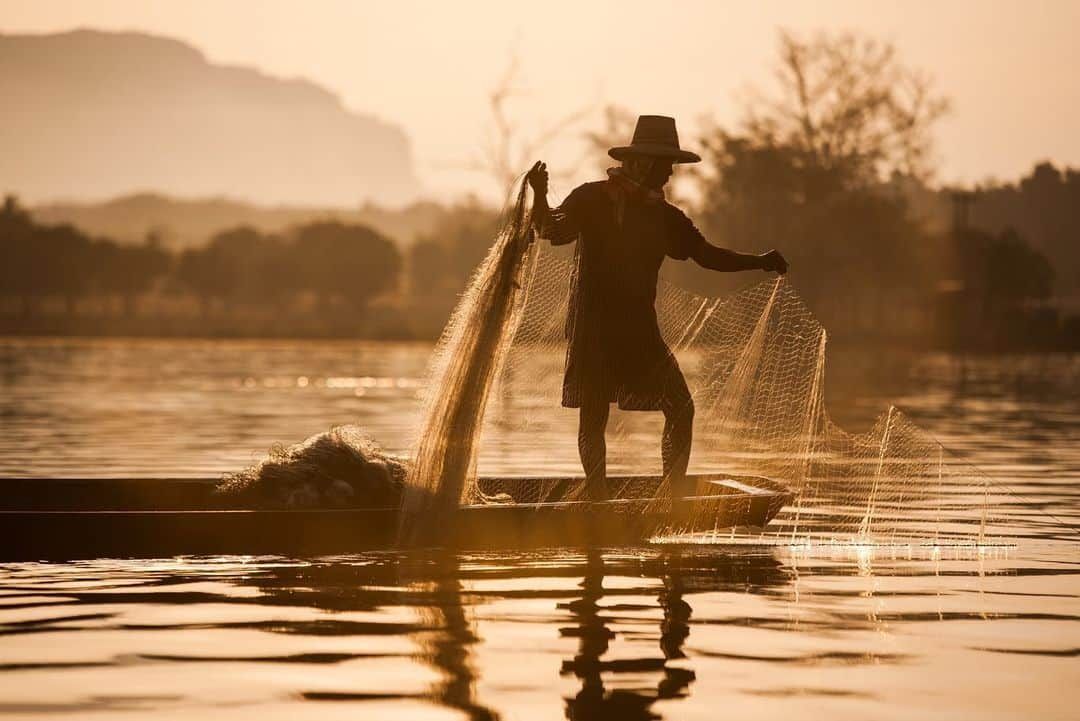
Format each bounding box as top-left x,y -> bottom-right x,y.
0,0 -> 1080,201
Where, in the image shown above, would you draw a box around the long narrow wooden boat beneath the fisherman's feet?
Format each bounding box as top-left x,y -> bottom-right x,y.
0,474 -> 791,559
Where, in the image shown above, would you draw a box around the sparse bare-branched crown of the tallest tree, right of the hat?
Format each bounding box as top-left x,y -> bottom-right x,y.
744,31 -> 948,178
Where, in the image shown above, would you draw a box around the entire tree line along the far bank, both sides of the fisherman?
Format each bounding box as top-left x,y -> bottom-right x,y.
0,33 -> 1080,348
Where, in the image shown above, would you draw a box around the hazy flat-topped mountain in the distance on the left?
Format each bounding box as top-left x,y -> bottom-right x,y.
0,30 -> 419,206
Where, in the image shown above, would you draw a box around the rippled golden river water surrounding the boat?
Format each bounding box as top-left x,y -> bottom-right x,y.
0,339 -> 1080,720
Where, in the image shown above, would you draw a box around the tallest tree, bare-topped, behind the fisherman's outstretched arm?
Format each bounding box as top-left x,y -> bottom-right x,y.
680,27 -> 945,331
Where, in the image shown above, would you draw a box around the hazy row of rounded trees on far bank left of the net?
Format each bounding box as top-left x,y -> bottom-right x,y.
0,191 -> 497,337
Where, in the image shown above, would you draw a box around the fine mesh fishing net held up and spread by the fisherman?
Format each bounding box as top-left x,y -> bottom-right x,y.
402,179 -> 1000,543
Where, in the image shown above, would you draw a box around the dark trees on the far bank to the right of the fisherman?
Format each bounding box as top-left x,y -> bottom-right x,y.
590,32 -> 1080,348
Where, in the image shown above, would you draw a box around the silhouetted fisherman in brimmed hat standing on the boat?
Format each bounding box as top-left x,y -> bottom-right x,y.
528,115 -> 787,499
